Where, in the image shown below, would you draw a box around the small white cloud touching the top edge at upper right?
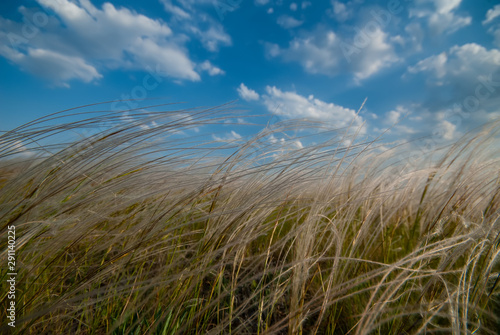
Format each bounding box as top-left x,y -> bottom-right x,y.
410,0 -> 472,35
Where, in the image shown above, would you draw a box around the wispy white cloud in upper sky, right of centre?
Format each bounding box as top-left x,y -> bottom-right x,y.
267,27 -> 399,81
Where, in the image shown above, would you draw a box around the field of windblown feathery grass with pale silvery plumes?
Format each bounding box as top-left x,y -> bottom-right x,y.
0,107 -> 500,335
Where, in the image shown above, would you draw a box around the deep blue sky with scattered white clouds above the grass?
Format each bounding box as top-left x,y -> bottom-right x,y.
0,0 -> 500,153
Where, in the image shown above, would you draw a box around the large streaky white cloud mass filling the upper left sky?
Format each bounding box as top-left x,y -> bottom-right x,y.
0,0 -> 231,86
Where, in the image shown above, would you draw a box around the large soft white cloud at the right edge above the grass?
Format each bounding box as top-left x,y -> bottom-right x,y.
408,43 -> 500,139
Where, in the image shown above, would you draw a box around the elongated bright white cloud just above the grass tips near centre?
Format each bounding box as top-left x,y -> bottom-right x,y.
262,86 -> 365,132
